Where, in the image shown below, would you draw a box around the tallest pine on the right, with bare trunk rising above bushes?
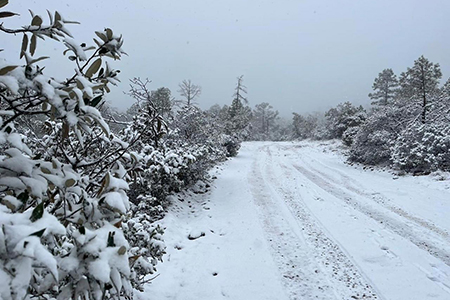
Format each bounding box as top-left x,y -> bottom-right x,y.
400,55 -> 442,123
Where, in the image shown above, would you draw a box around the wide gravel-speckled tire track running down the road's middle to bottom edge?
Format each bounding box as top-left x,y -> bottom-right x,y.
250,147 -> 380,300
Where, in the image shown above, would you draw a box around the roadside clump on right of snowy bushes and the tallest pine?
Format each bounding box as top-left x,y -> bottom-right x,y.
349,56 -> 450,173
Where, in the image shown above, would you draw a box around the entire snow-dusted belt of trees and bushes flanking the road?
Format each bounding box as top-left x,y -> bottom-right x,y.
0,0 -> 450,300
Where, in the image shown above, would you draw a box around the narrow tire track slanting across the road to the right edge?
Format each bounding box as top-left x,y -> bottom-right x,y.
292,159 -> 450,266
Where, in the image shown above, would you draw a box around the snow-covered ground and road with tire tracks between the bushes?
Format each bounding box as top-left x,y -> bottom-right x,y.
139,142 -> 450,300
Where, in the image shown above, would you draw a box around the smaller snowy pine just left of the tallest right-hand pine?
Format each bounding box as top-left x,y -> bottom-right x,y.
369,69 -> 398,105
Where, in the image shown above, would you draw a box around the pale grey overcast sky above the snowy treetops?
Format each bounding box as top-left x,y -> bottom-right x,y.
0,0 -> 450,115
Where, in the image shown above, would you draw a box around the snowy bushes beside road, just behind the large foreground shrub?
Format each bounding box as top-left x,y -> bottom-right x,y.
122,84 -> 236,221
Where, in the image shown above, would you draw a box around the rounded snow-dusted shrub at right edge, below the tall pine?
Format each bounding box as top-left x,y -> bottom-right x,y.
392,123 -> 450,173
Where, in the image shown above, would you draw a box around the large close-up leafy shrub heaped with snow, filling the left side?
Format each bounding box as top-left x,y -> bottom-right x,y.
0,2 -> 156,300
